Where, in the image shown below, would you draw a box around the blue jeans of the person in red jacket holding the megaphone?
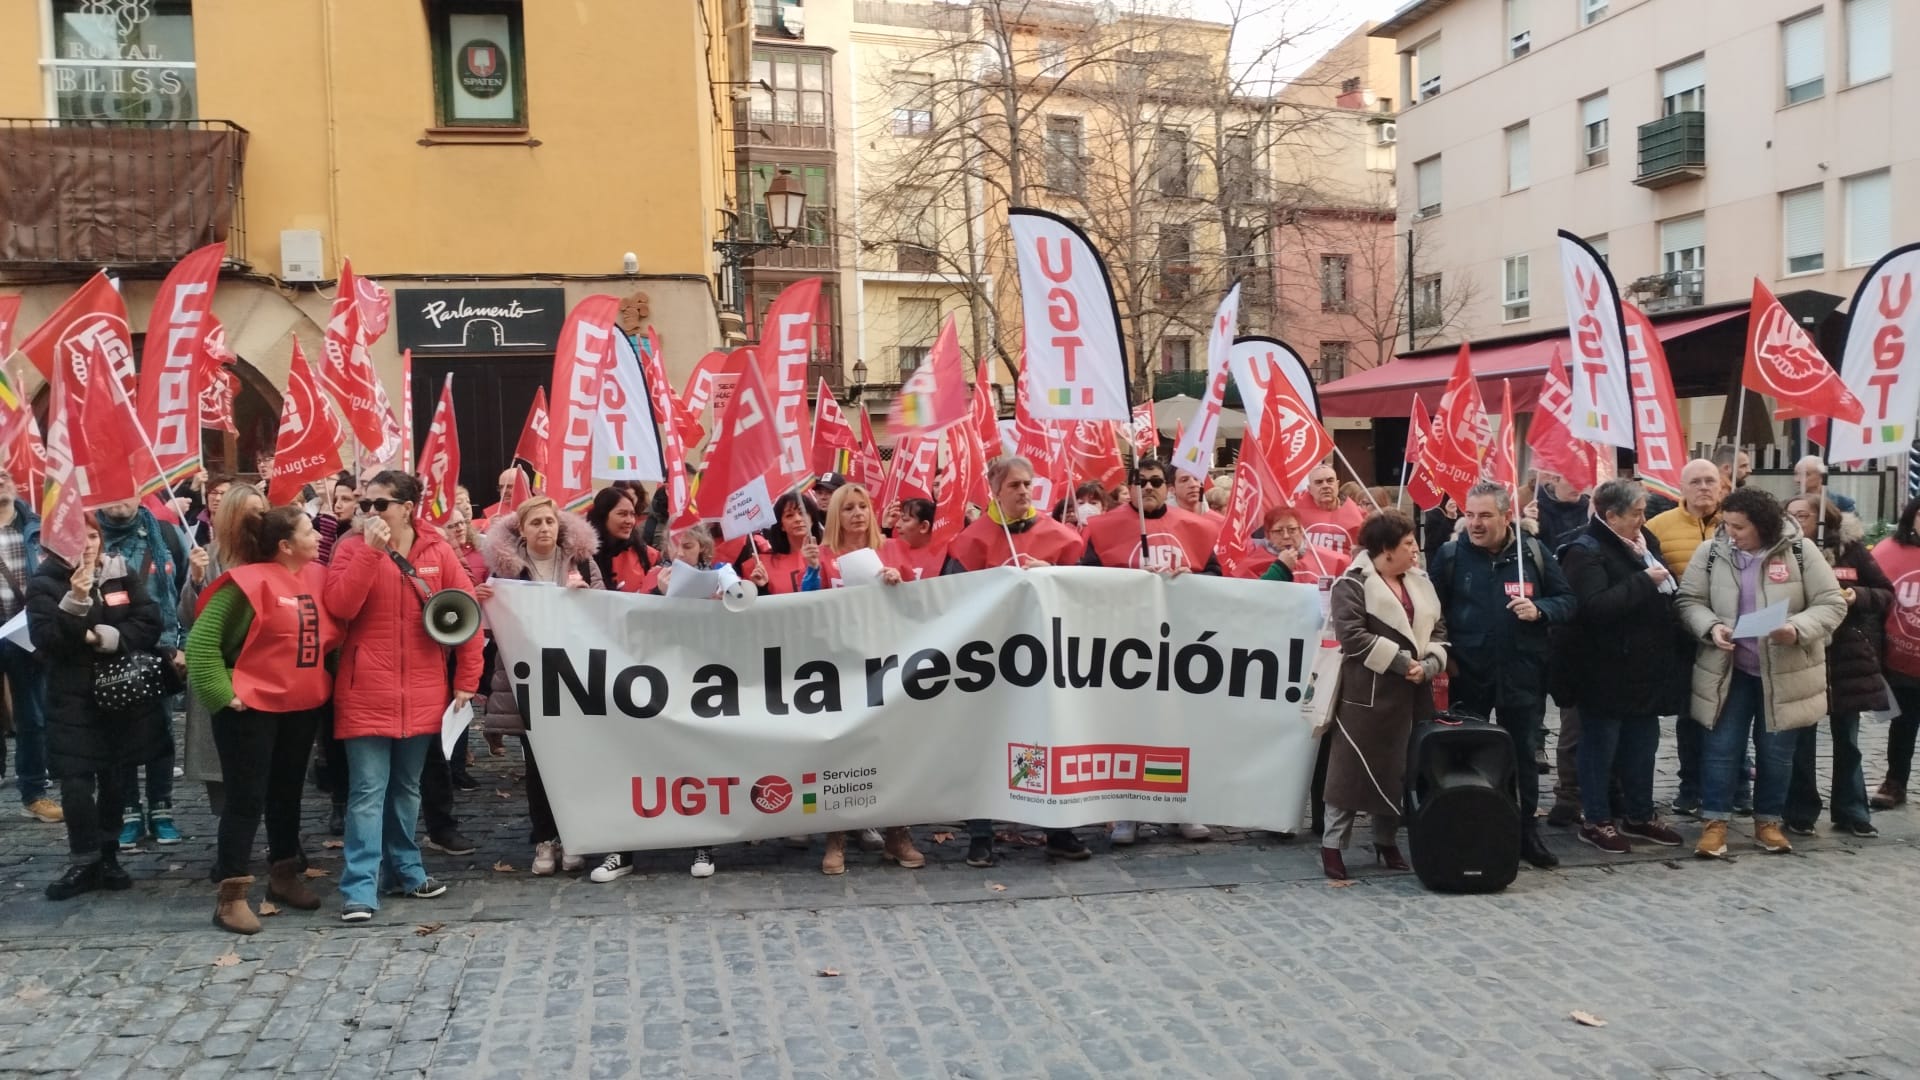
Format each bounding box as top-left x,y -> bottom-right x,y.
340,734 -> 436,909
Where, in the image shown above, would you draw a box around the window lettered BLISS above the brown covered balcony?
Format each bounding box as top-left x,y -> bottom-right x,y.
42,0 -> 200,121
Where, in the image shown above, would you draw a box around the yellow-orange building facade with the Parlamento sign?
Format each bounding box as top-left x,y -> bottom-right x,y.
0,0 -> 751,490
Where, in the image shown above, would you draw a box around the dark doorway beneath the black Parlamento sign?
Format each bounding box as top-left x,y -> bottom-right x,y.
413,356 -> 553,509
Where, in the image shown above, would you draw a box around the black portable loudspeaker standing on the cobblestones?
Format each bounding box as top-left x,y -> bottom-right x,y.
1405,713 -> 1521,892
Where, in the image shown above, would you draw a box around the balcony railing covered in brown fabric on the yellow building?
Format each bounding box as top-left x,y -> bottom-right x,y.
0,117 -> 248,269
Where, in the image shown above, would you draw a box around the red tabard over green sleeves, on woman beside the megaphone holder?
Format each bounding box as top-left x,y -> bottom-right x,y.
224,563 -> 342,713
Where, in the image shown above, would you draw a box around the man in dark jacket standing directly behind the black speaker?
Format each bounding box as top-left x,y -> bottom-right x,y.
1427,480 -> 1576,869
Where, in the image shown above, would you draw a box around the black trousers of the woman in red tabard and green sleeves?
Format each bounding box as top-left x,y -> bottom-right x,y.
211,709 -> 321,882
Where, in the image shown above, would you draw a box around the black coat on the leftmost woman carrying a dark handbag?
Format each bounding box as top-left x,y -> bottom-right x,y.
27,553 -> 173,778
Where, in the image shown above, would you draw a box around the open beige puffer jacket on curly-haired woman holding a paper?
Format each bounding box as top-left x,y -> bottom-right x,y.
1676,519 -> 1847,732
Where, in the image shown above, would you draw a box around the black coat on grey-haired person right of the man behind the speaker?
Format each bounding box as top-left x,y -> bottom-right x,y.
1553,519 -> 1695,717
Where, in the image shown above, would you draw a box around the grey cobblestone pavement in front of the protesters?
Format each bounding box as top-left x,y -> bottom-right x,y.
0,707 -> 1920,1080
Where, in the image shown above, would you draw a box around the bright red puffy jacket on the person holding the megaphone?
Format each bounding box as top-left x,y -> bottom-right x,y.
326,532 -> 482,738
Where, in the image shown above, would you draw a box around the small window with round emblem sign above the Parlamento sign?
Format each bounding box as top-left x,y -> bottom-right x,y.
428,0 -> 526,127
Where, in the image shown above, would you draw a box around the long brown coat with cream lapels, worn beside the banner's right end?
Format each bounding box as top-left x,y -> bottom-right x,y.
1327,552 -> 1448,815
